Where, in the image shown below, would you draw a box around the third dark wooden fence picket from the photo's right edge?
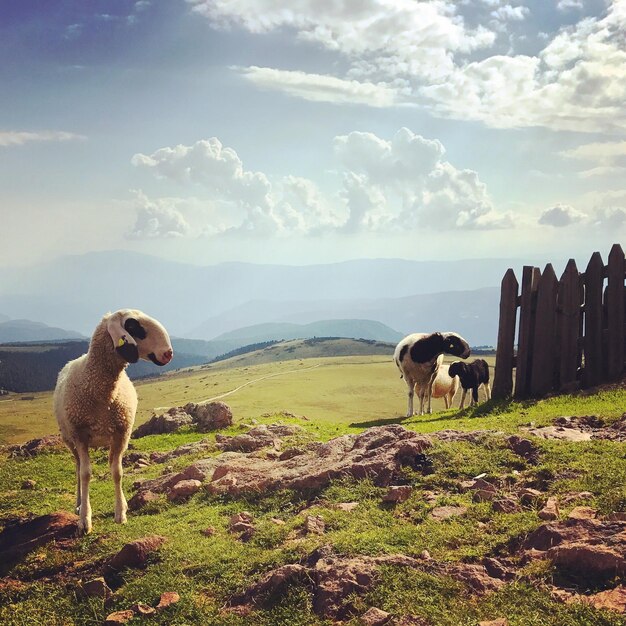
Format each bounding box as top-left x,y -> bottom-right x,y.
557,259 -> 581,392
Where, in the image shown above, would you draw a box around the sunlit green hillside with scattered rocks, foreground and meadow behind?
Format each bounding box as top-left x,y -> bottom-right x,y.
0,357 -> 626,626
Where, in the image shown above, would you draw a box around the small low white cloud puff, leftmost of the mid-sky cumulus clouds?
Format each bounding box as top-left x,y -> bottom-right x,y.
128,191 -> 190,239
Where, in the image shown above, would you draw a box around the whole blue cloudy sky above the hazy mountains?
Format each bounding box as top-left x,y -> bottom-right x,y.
0,0 -> 626,267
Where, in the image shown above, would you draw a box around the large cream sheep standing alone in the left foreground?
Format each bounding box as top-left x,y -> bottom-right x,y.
53,309 -> 174,534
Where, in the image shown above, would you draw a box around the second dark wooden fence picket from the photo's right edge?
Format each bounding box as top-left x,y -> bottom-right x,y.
583,252 -> 604,387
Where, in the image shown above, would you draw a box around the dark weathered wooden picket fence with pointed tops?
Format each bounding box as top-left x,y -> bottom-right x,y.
493,244 -> 626,398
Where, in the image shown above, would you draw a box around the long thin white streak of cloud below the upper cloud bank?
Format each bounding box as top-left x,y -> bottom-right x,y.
236,66 -> 399,107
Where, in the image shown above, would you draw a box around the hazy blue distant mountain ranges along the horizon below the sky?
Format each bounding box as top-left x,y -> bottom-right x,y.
0,251 -> 544,345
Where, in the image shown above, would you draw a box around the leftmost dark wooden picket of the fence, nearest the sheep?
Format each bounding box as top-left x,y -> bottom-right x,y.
493,269 -> 518,398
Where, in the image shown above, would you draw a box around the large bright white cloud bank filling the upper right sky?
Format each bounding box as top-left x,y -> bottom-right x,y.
188,0 -> 626,133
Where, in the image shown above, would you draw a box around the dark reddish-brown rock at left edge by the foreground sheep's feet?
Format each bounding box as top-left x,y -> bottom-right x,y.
0,511 -> 78,563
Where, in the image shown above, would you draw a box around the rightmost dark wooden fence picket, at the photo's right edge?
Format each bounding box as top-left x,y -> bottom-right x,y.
607,243 -> 625,380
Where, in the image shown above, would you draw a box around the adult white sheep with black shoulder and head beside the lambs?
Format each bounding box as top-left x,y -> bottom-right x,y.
393,332 -> 470,417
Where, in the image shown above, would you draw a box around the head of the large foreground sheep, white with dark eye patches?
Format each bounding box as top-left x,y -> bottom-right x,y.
107,309 -> 174,365
